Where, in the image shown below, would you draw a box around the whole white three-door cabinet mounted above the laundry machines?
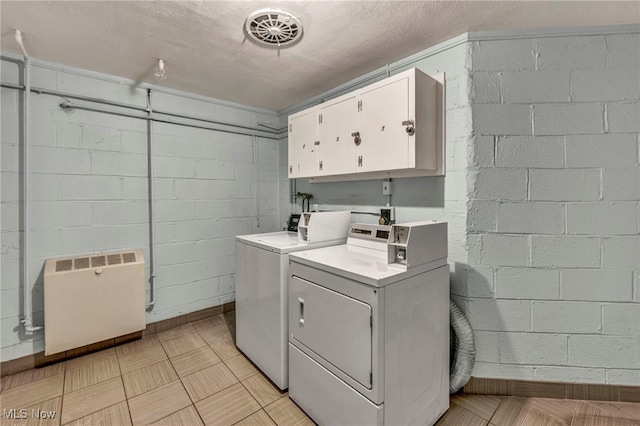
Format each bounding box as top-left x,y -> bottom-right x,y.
289,68 -> 444,182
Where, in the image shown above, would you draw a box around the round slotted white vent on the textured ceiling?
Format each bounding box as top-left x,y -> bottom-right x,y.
245,9 -> 302,47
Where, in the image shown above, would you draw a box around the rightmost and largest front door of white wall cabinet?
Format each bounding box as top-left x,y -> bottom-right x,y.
356,77 -> 410,172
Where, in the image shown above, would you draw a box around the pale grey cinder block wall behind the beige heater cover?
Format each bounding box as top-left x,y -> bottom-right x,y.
0,61 -> 280,361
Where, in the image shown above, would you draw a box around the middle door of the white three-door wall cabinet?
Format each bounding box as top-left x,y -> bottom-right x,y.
318,95 -> 358,176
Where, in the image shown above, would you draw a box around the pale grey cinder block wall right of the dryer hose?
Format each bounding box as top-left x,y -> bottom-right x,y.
464,33 -> 640,385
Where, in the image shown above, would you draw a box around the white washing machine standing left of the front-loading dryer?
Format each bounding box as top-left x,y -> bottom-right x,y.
235,211 -> 351,390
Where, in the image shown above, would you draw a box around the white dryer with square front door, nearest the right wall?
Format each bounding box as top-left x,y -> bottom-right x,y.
289,221 -> 449,426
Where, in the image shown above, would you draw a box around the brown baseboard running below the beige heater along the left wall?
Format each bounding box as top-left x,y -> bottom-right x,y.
0,302 -> 236,377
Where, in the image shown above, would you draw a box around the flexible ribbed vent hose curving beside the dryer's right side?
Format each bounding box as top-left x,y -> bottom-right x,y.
449,300 -> 476,394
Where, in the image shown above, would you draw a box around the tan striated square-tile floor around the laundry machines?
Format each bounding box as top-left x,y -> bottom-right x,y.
0,312 -> 640,426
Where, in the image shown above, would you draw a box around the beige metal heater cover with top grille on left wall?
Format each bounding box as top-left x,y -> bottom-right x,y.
44,250 -> 146,355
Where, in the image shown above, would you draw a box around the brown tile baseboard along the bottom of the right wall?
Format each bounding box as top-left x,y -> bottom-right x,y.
464,377 -> 640,402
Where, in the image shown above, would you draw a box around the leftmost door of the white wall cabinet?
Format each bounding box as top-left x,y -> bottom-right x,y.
289,109 -> 318,178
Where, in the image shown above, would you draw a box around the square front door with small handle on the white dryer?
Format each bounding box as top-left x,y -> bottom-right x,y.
290,276 -> 372,389
